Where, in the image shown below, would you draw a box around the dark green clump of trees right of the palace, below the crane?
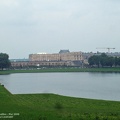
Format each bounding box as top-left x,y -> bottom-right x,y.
88,53 -> 120,67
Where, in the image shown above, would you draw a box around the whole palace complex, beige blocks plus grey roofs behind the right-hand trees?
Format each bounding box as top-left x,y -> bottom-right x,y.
10,50 -> 120,68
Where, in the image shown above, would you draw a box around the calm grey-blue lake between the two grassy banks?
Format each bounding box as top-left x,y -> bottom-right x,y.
0,72 -> 120,101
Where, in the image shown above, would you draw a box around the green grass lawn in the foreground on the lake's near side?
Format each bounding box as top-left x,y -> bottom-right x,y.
0,85 -> 120,120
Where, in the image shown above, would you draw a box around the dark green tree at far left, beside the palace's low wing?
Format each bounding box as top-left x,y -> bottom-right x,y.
0,53 -> 11,70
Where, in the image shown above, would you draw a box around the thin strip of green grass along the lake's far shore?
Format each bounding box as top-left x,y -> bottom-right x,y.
0,68 -> 120,74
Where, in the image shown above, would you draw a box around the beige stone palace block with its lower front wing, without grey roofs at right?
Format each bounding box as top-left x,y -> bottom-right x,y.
11,50 -> 83,68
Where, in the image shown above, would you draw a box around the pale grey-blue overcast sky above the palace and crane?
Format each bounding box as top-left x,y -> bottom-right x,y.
0,0 -> 120,59
